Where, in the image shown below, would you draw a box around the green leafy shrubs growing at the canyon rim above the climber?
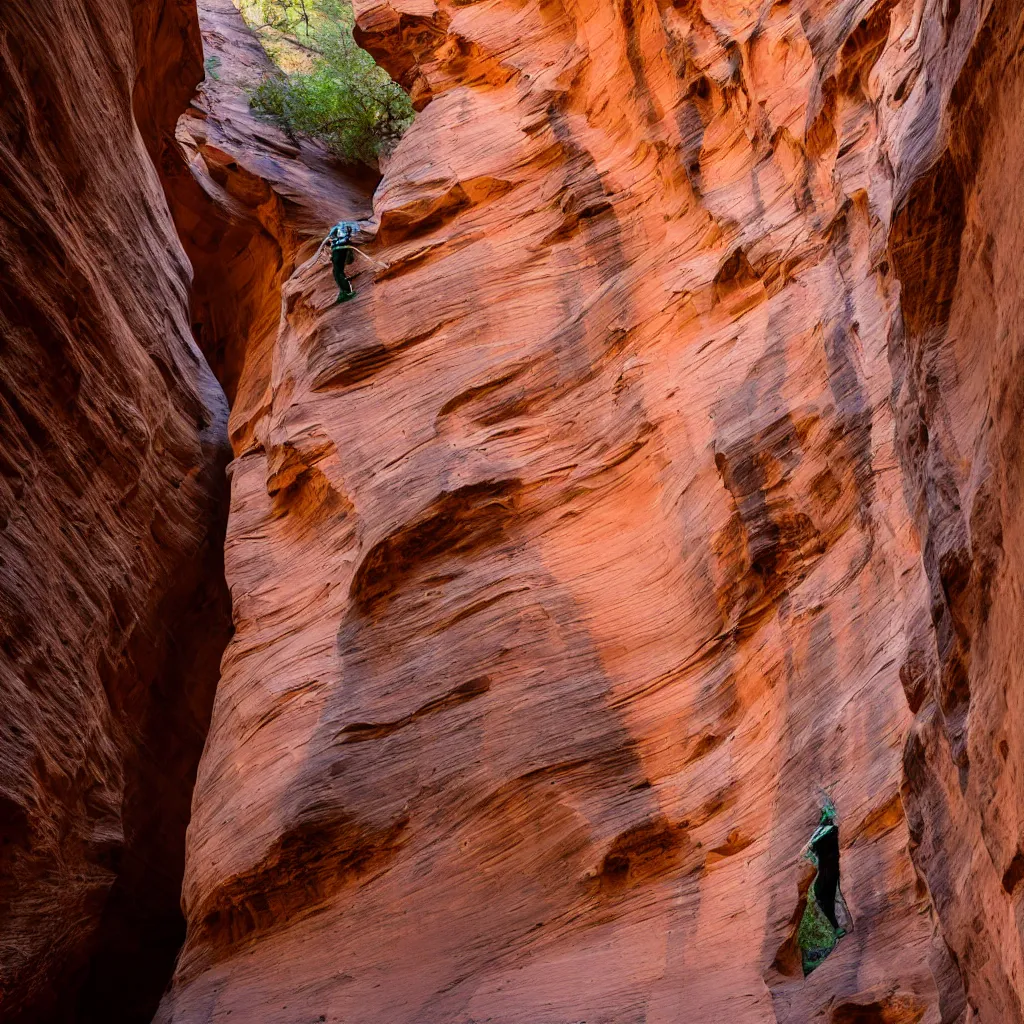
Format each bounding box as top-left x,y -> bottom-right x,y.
236,0 -> 413,167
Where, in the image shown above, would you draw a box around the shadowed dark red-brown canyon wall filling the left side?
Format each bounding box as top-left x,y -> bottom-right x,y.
0,0 -> 230,1024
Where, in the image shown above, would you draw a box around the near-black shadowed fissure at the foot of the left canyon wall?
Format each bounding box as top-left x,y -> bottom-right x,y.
75,468 -> 230,1024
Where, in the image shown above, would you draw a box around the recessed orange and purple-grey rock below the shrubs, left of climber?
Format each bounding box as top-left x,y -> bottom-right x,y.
153,0 -> 379,455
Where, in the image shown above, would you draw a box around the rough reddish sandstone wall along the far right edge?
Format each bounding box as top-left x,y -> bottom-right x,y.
891,4 -> 1024,1021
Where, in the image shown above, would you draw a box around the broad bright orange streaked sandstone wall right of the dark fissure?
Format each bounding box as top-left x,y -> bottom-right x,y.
149,0 -> 1024,1024
